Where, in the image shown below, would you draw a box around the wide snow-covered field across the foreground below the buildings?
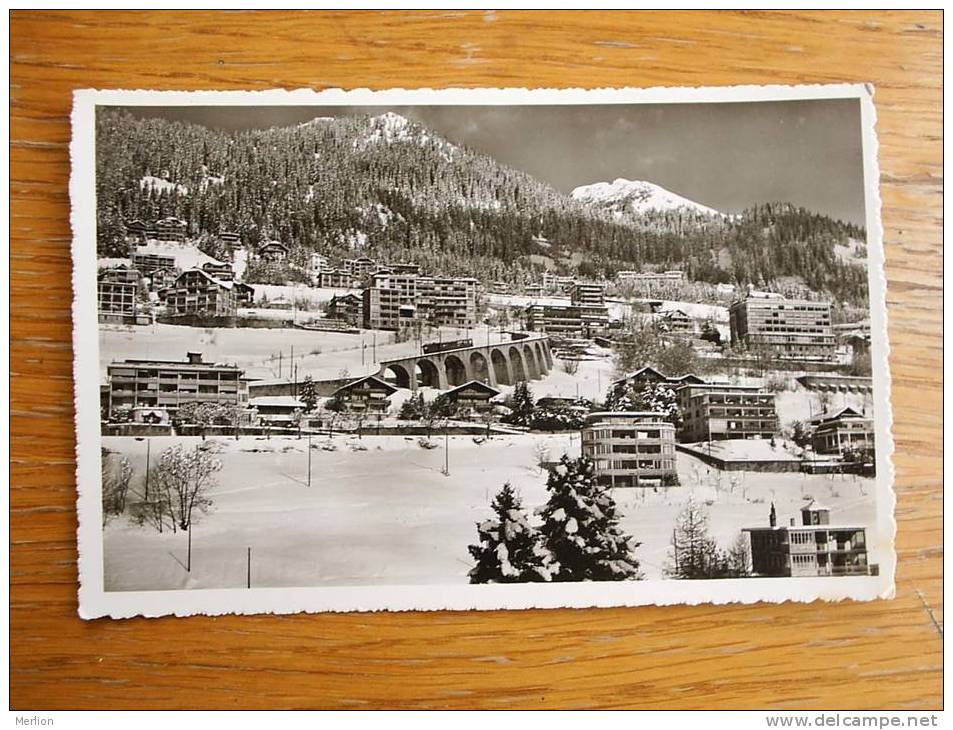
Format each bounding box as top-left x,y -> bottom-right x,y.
103,435 -> 887,590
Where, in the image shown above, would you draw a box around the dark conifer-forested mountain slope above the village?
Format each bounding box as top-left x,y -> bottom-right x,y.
97,110 -> 866,303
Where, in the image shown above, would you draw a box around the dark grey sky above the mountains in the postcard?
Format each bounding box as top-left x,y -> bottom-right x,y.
115,99 -> 865,225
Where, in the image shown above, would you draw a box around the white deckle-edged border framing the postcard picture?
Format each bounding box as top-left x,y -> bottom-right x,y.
70,84 -> 896,619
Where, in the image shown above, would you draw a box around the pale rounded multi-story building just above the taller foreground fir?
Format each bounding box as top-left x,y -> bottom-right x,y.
582,411 -> 678,487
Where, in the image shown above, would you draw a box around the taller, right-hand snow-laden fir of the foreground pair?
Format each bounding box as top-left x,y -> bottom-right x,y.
539,454 -> 642,581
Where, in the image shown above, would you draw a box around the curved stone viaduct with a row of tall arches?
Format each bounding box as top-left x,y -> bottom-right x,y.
378,335 -> 553,390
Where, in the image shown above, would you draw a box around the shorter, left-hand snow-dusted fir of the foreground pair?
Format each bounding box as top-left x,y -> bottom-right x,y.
469,484 -> 552,583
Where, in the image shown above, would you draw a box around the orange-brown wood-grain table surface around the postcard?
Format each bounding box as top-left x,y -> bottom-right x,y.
10,11 -> 943,710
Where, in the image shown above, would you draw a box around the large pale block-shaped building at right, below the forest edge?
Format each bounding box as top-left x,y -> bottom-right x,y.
728,292 -> 836,360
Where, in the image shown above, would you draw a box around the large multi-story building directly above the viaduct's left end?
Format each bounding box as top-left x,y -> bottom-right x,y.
363,272 -> 477,330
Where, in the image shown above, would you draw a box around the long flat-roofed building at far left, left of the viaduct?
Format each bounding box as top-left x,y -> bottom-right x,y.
106,352 -> 248,420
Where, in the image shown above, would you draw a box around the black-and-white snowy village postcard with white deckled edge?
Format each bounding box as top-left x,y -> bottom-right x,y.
70,85 -> 896,618
